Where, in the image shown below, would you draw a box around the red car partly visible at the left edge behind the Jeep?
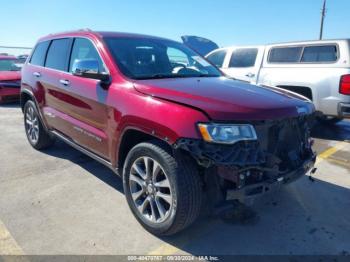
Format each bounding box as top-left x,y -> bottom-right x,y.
0,55 -> 21,103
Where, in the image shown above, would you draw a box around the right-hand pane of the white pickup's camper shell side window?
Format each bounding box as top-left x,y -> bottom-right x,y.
301,45 -> 338,63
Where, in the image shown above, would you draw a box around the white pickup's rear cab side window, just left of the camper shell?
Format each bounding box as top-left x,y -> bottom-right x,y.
229,48 -> 258,67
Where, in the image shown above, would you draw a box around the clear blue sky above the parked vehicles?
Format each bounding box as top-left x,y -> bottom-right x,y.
0,0 -> 350,54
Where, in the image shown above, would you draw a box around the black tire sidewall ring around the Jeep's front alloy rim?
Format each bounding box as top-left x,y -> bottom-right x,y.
123,143 -> 179,234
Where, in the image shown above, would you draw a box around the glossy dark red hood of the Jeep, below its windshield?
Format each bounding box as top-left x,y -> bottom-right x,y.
134,77 -> 314,121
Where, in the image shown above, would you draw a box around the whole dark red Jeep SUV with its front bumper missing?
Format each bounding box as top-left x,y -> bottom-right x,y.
21,31 -> 315,235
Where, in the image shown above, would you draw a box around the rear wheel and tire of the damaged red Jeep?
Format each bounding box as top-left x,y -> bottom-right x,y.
23,100 -> 55,150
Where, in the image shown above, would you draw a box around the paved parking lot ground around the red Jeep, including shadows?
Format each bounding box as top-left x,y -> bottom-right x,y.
0,104 -> 350,255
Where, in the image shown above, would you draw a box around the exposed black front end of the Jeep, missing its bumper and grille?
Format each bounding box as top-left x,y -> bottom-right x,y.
174,115 -> 316,201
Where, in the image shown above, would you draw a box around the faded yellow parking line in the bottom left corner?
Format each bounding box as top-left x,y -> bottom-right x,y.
0,220 -> 24,255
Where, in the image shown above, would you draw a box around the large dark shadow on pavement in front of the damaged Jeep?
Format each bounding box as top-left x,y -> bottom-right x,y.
158,177 -> 350,256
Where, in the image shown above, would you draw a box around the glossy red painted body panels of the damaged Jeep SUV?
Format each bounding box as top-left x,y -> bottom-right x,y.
22,31 -> 313,168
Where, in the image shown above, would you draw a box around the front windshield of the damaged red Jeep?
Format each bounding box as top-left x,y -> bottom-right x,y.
105,37 -> 221,79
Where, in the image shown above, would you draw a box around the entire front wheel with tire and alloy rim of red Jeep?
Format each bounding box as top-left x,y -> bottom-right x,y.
123,141 -> 202,235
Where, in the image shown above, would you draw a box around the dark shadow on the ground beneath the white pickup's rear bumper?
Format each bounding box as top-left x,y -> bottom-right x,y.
311,120 -> 350,141
